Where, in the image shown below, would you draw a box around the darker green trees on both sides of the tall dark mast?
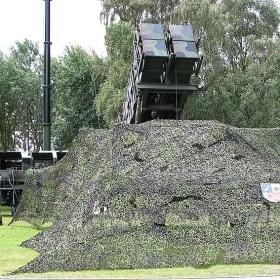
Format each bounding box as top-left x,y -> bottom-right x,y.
0,40 -> 106,151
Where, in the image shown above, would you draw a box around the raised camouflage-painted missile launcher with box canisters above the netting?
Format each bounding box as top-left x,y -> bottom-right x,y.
118,23 -> 203,124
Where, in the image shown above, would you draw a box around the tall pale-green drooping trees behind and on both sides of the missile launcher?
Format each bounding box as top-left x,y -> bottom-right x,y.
100,0 -> 280,127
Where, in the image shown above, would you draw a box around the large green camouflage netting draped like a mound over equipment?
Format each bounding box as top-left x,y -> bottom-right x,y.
16,121 -> 280,272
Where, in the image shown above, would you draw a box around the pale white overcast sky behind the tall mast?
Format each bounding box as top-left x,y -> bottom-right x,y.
0,0 -> 280,56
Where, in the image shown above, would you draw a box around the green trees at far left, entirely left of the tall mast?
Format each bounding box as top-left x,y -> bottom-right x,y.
0,40 -> 42,151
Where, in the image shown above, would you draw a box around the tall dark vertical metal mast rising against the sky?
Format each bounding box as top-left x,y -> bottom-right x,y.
43,0 -> 52,151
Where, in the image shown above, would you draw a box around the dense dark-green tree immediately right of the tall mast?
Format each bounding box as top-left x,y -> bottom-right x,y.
53,47 -> 106,149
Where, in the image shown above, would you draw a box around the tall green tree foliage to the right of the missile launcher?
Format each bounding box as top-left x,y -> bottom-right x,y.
183,0 -> 279,127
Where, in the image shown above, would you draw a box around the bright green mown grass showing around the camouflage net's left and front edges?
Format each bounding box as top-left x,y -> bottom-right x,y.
0,207 -> 280,279
